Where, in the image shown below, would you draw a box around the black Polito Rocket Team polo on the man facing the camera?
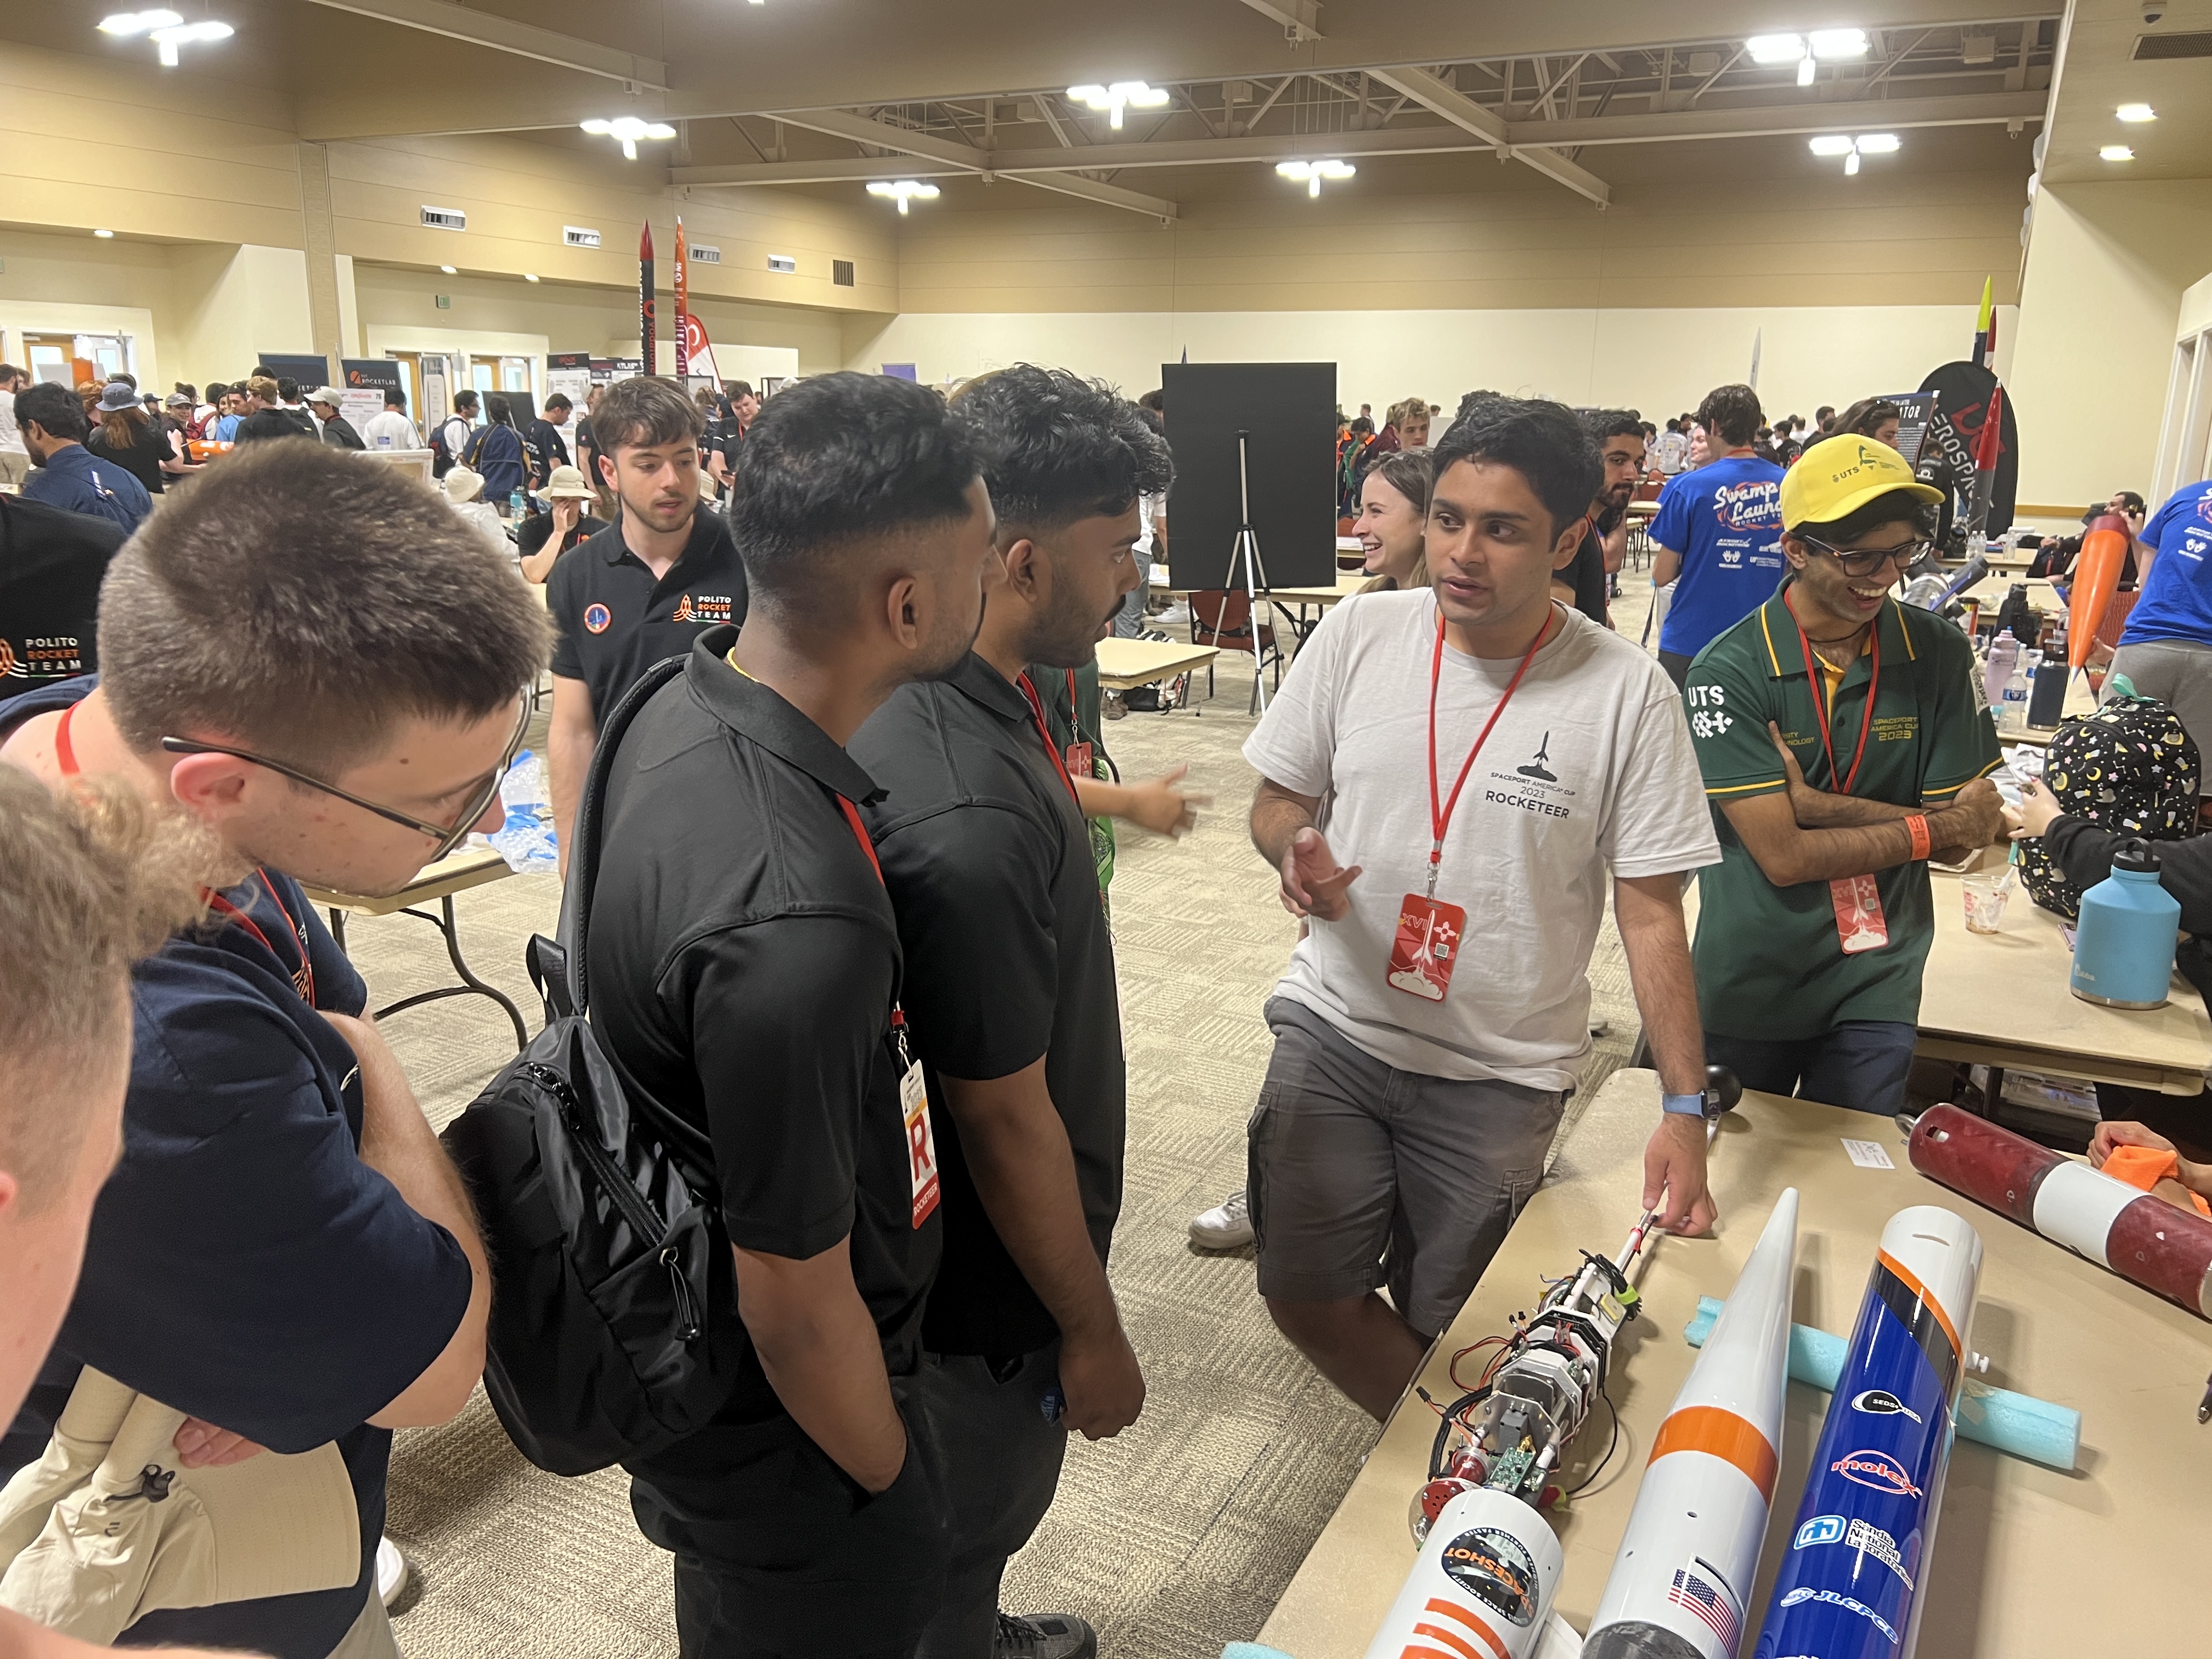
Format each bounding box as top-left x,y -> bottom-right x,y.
546,513 -> 746,719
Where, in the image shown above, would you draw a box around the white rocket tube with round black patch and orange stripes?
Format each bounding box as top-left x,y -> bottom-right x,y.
1367,1487 -> 1566,1659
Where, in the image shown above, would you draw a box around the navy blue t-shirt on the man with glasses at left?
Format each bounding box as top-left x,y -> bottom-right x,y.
7,677 -> 471,1659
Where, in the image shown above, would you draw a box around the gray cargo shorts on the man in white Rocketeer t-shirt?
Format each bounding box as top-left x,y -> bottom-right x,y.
1245,997 -> 1566,1336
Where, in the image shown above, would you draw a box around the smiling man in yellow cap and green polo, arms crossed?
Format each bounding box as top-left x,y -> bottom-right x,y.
1683,433 -> 2000,1113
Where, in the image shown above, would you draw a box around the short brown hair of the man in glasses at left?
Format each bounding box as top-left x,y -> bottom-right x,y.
99,444 -> 551,774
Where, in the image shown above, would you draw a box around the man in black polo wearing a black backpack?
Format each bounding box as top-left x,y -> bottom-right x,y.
588,374 -> 1005,1659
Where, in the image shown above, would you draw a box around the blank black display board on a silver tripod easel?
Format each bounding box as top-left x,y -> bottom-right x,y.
1159,363 -> 1336,589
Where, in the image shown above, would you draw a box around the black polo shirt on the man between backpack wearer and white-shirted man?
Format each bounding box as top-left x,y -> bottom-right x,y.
851,654 -> 1128,1358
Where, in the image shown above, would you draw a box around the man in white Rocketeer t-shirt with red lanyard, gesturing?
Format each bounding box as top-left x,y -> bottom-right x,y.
1245,398 -> 1721,1418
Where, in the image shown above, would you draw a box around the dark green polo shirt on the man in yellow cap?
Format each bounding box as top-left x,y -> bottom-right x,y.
1683,589 -> 2002,1040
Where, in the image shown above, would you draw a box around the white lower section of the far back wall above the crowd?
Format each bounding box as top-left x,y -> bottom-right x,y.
845,305 -> 2017,420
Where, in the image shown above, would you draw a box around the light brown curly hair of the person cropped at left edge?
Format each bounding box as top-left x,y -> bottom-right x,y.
0,765 -> 211,1210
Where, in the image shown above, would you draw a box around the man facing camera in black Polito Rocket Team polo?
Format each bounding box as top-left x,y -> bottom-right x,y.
546,374 -> 746,874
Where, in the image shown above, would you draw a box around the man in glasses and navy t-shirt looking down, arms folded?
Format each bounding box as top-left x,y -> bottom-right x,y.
0,444 -> 551,1659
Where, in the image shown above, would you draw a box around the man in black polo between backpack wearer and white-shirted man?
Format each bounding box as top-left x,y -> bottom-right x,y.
845,365 -> 1172,1659
